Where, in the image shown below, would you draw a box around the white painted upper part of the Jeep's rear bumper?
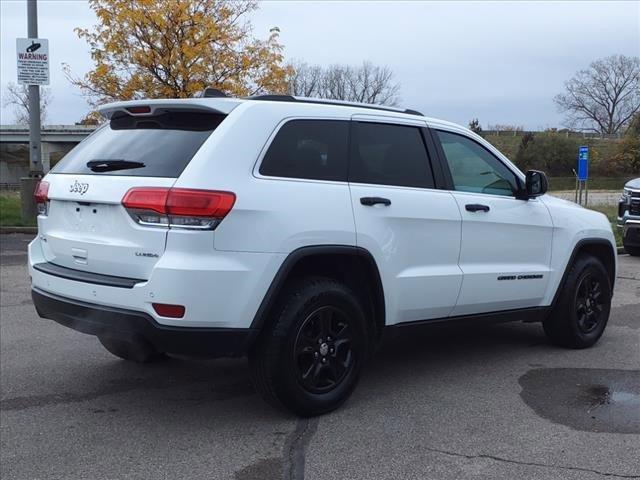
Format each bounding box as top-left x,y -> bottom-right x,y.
29,232 -> 285,330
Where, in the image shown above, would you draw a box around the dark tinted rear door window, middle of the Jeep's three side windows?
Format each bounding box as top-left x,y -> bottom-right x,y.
349,122 -> 434,188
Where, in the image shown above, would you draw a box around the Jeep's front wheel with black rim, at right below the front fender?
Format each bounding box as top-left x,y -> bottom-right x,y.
542,255 -> 611,348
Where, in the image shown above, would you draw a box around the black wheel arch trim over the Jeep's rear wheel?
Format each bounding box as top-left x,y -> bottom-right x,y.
250,245 -> 385,330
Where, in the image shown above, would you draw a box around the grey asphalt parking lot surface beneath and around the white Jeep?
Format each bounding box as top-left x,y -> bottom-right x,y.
0,235 -> 640,480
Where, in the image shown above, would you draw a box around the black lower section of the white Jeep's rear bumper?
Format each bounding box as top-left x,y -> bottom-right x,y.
31,288 -> 257,358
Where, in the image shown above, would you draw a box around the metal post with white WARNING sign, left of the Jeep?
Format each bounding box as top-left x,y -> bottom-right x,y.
16,0 -> 49,223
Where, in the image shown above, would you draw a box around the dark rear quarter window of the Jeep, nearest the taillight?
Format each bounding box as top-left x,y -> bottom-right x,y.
260,120 -> 349,181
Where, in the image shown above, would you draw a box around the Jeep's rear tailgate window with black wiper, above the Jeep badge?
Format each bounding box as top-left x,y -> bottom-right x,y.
52,111 -> 225,178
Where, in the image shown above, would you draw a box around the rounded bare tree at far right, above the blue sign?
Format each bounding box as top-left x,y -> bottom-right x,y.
554,55 -> 640,134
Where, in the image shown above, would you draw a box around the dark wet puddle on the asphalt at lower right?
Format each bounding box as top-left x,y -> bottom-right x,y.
519,368 -> 640,433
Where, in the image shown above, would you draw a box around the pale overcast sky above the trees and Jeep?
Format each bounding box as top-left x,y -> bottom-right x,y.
0,0 -> 640,129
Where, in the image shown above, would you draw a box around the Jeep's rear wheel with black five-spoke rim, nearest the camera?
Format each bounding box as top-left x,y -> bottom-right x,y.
249,277 -> 369,417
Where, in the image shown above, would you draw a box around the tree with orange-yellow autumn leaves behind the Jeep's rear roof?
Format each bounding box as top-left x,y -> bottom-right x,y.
64,0 -> 291,106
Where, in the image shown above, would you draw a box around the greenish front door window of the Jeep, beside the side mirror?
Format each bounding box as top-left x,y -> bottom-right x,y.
437,131 -> 516,196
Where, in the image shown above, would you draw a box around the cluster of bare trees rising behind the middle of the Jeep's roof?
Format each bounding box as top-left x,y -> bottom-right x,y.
289,62 -> 400,105
